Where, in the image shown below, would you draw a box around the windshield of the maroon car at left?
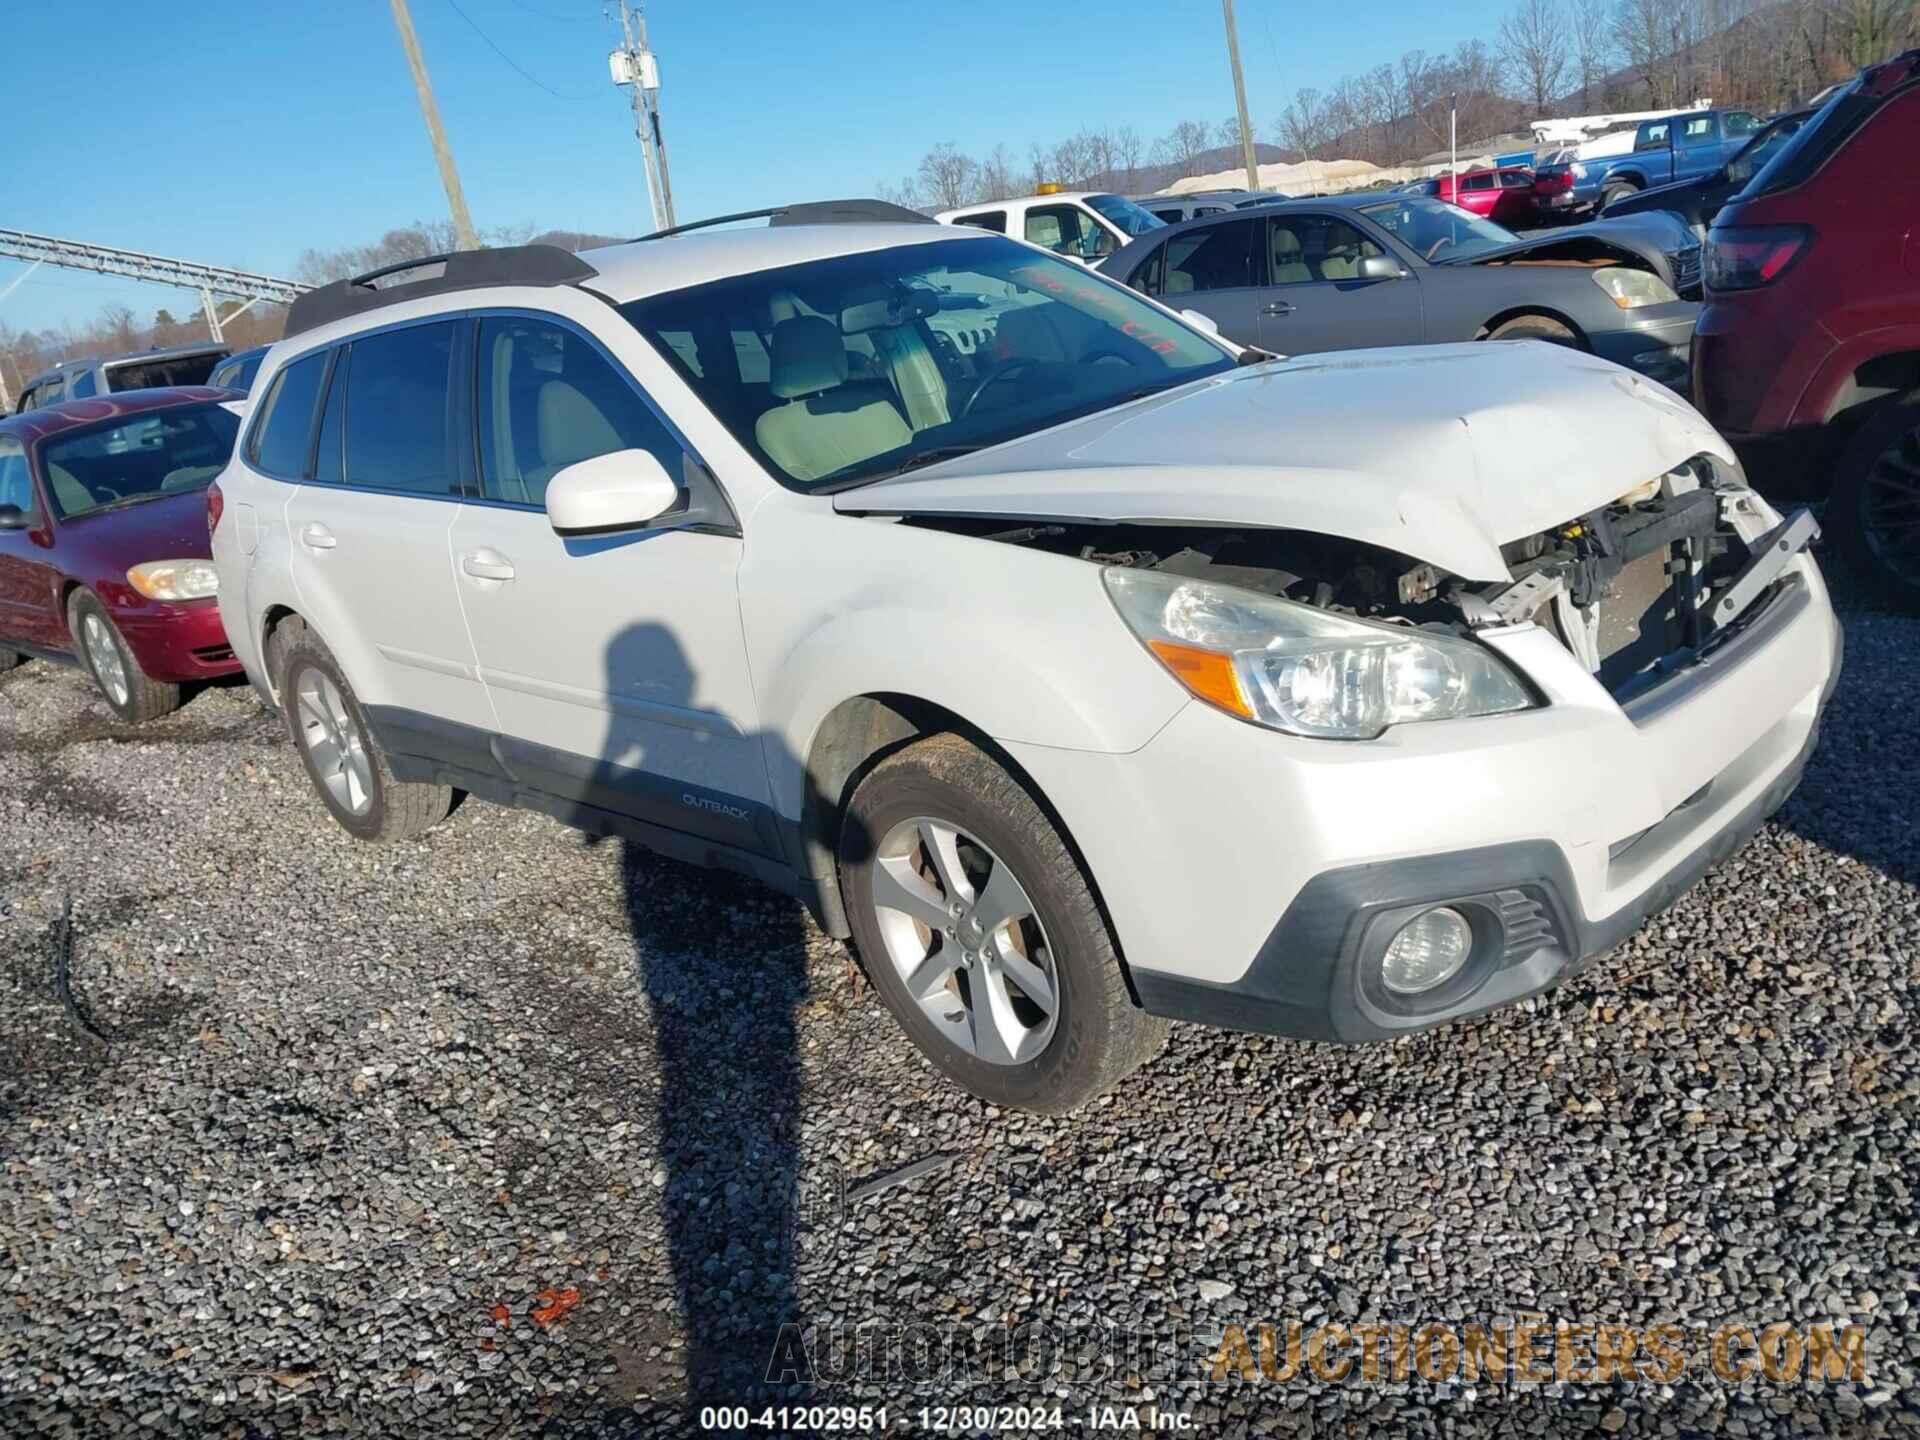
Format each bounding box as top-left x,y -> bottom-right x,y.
40,405 -> 240,520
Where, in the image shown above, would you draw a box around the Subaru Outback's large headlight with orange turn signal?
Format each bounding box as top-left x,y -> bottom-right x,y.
1102,568 -> 1534,739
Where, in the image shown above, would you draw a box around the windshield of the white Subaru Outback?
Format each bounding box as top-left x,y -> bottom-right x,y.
620,234 -> 1235,490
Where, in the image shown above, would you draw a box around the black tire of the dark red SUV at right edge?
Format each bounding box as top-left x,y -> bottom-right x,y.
1824,390 -> 1920,614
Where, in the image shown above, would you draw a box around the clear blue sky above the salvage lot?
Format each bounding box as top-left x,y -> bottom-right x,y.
0,0 -> 1505,328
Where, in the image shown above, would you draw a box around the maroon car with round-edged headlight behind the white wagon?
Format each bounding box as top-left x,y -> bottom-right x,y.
0,386 -> 242,720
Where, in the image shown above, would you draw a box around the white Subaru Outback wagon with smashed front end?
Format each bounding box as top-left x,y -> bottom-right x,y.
209,202 -> 1839,1110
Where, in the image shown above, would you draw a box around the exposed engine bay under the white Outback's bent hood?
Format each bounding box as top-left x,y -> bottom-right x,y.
906,457 -> 1818,699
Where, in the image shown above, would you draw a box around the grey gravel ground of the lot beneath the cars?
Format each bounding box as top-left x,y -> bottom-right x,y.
0,568 -> 1920,1436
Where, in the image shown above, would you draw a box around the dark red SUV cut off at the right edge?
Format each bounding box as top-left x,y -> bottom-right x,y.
1693,50 -> 1920,611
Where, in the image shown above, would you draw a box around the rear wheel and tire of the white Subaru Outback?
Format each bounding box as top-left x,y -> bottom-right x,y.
267,620 -> 453,843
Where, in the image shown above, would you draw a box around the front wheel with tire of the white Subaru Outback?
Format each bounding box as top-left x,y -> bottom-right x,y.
839,735 -> 1167,1114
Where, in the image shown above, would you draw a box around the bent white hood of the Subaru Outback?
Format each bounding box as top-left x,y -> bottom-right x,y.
833,342 -> 1728,580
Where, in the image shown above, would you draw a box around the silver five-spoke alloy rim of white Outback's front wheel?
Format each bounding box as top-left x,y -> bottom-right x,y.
874,816 -> 1060,1066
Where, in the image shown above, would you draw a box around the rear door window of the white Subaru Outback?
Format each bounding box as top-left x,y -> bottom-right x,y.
346,321 -> 461,495
